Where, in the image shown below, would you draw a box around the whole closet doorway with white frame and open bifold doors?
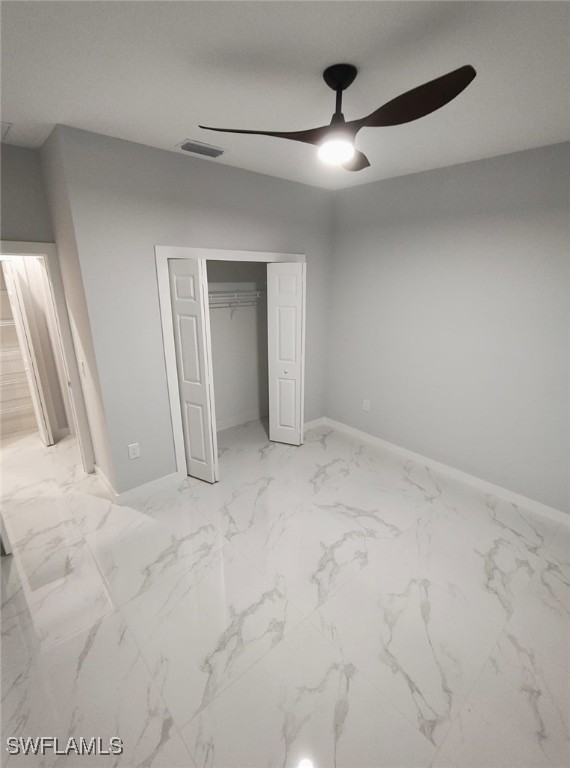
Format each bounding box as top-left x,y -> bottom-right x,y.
155,246 -> 306,483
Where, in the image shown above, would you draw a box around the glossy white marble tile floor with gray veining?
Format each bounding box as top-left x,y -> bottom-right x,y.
1,422 -> 570,768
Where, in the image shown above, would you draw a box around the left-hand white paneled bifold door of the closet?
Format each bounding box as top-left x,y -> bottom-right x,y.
168,259 -> 218,483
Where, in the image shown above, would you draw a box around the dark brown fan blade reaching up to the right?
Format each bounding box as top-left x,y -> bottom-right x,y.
360,65 -> 477,128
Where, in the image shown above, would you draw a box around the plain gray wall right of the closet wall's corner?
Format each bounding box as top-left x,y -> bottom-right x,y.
326,144 -> 570,511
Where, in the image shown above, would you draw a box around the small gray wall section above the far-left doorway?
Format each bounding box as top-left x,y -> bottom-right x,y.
0,144 -> 53,243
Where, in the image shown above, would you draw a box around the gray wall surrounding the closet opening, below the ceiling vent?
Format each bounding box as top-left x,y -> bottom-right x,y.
45,126 -> 332,492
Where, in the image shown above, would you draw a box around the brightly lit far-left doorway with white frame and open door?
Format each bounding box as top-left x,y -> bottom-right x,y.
0,240 -> 94,473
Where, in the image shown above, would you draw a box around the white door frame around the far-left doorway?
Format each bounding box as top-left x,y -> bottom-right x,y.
0,240 -> 95,473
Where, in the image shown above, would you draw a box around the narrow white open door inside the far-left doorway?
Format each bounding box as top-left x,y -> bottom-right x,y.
4,261 -> 54,445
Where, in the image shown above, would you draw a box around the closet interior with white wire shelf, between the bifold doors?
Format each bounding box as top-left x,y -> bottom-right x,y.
207,261 -> 269,432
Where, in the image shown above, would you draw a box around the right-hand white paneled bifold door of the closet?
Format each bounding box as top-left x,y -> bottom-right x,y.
267,262 -> 306,445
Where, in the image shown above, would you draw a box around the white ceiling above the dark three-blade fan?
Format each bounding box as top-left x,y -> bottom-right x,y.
1,0 -> 570,188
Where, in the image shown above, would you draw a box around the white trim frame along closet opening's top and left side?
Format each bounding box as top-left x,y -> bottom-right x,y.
154,245 -> 307,476
